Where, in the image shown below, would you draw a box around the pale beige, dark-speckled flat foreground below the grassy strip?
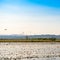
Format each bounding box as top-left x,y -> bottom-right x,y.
0,42 -> 60,60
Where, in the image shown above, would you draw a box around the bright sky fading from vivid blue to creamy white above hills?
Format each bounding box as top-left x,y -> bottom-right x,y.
0,0 -> 60,34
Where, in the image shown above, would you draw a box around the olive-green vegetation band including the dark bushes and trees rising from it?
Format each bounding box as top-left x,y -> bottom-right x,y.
0,36 -> 60,42
